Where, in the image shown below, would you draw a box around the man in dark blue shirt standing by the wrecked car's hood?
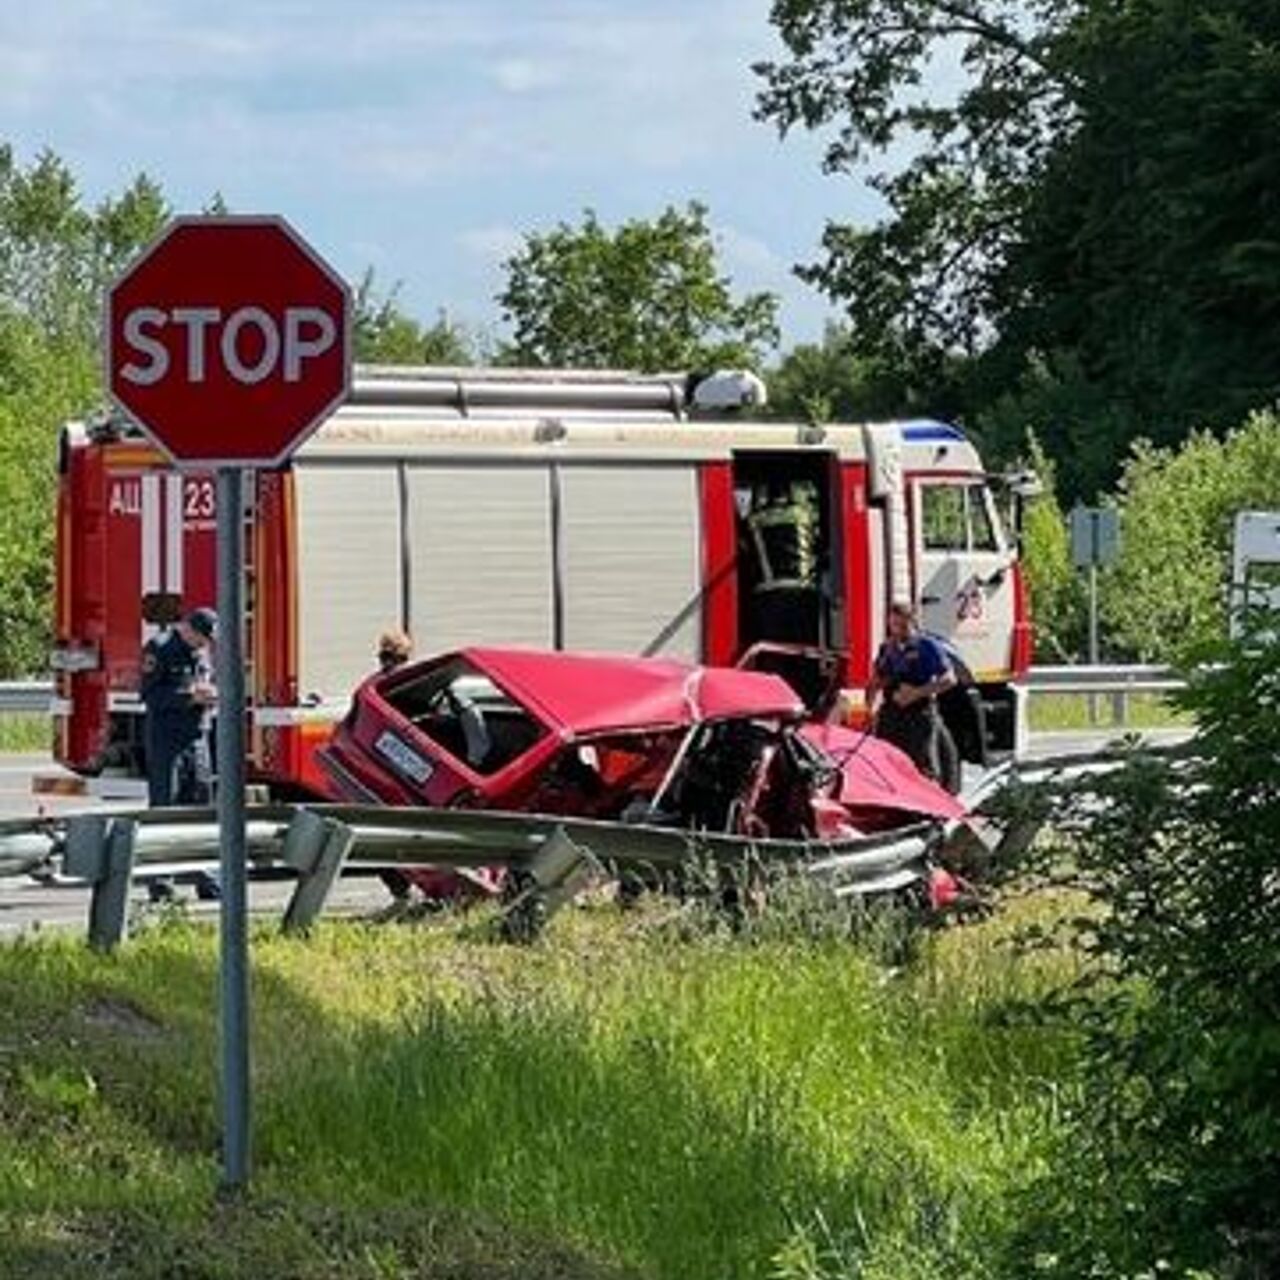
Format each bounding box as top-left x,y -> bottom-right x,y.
867,602 -> 956,782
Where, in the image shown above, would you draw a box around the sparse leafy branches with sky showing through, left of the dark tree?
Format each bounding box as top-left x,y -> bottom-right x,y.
755,0 -> 1075,356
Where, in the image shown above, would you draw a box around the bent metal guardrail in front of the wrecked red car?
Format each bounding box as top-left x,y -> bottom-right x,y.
0,804 -> 946,947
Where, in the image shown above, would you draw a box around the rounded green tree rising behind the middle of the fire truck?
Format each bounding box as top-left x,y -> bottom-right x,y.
498,202 -> 778,371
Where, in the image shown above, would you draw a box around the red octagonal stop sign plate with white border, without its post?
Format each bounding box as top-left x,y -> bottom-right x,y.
106,218 -> 351,467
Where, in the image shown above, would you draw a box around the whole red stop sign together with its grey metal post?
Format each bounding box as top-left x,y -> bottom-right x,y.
104,216 -> 352,1190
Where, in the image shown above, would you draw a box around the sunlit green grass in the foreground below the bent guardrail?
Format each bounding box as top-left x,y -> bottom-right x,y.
0,909 -> 1071,1280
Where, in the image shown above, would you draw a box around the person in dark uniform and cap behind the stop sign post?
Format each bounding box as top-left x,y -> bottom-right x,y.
141,609 -> 218,806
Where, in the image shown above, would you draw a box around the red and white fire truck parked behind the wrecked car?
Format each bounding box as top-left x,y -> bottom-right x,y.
51,367 -> 1032,795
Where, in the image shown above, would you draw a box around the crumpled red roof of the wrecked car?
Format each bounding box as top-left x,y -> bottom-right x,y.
460,649 -> 804,736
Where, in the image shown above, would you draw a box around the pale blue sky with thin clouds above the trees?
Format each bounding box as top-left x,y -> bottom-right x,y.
0,0 -> 876,342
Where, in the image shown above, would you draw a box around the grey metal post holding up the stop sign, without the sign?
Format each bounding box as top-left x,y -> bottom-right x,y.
215,467 -> 250,1190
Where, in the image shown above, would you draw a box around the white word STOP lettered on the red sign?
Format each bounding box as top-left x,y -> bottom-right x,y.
120,306 -> 338,387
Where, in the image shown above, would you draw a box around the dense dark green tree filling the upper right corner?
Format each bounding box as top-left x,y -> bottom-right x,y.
998,0 -> 1280,481
